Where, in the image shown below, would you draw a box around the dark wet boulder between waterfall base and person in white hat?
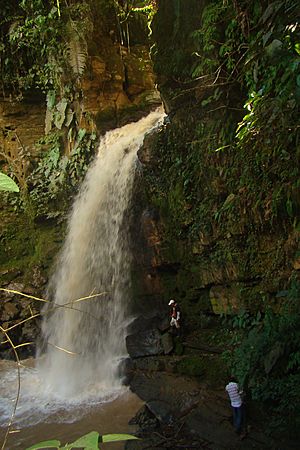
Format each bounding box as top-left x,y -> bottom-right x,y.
126,329 -> 163,358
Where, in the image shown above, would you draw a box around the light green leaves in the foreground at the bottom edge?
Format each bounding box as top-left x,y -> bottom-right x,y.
26,431 -> 138,450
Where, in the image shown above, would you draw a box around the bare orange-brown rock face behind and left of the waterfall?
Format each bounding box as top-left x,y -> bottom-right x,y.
0,1 -> 161,356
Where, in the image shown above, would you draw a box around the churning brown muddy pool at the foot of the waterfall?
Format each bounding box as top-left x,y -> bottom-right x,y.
0,361 -> 143,450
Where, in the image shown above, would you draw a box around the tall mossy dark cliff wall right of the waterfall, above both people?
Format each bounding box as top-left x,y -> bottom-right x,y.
137,0 -> 300,316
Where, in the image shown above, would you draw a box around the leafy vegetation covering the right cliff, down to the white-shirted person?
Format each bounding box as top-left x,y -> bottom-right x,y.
145,0 -> 300,431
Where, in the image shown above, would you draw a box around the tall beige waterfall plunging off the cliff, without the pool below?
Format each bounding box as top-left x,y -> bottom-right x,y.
39,110 -> 163,398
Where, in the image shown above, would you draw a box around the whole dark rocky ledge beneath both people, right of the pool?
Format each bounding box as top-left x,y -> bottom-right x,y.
125,315 -> 297,450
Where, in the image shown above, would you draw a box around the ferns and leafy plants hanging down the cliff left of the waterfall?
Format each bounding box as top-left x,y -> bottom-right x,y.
0,0 -> 155,219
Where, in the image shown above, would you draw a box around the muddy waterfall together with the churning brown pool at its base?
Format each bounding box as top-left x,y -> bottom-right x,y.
0,109 -> 164,450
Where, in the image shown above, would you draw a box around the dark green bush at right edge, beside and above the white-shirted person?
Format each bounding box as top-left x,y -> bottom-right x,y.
227,280 -> 300,432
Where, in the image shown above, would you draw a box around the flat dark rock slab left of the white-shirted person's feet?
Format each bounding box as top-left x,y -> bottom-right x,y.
126,372 -> 274,450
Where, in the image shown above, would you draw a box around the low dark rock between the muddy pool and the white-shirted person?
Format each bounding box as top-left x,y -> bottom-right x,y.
126,373 -> 274,450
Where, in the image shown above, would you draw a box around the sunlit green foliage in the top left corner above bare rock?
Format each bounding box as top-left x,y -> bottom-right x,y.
0,0 -> 92,99
